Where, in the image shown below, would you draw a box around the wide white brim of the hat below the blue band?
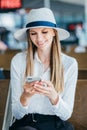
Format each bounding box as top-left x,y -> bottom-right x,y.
14,26 -> 70,42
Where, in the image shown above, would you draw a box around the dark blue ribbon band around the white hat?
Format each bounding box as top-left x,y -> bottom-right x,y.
26,21 -> 57,27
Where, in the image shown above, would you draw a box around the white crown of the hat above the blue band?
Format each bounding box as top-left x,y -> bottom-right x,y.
26,8 -> 56,24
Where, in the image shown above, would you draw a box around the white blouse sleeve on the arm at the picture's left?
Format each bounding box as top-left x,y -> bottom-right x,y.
10,54 -> 28,119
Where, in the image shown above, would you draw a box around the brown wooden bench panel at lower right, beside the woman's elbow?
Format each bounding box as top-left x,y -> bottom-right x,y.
69,80 -> 87,130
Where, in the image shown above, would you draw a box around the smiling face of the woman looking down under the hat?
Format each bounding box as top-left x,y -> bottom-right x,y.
29,27 -> 55,49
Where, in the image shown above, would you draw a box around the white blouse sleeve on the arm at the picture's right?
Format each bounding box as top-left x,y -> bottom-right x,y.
53,59 -> 78,120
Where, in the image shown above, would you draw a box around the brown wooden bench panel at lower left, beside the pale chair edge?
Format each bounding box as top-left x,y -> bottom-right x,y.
0,79 -> 9,130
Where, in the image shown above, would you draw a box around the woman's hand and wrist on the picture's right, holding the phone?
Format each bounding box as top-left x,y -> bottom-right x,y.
34,81 -> 59,105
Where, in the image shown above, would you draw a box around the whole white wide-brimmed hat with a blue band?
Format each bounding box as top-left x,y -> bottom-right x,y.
14,7 -> 70,41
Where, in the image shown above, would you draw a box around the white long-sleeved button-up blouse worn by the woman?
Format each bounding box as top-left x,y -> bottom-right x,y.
10,52 -> 78,120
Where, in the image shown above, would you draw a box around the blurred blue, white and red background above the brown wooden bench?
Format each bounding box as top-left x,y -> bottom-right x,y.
0,0 -> 87,50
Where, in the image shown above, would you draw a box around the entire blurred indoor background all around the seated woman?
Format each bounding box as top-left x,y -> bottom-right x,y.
0,0 -> 87,130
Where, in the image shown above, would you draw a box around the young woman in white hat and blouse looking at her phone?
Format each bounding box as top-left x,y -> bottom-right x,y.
9,8 -> 78,130
